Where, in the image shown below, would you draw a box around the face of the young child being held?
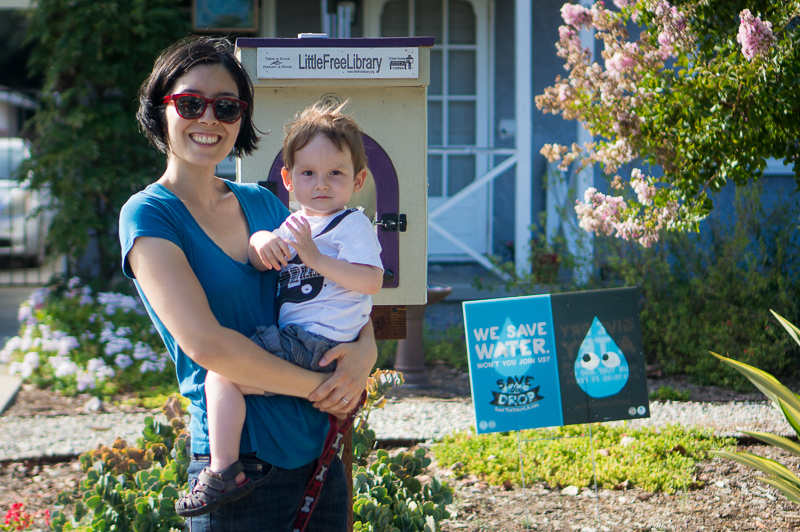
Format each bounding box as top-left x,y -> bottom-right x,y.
281,134 -> 367,216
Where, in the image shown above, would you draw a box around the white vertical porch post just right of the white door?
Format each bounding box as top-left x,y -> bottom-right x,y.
514,0 -> 533,273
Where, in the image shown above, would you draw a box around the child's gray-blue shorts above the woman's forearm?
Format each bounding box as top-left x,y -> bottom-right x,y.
250,324 -> 341,373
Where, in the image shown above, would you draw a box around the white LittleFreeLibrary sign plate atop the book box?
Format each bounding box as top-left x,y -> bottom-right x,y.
256,47 -> 419,79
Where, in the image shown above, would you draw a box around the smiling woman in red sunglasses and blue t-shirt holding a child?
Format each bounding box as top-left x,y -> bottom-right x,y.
120,37 -> 377,532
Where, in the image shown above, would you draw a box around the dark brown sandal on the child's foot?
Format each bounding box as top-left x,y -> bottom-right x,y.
175,461 -> 255,517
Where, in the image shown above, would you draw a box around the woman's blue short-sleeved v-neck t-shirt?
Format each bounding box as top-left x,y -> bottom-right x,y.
119,182 -> 328,469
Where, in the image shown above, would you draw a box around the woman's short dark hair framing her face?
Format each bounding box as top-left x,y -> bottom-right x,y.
136,36 -> 259,157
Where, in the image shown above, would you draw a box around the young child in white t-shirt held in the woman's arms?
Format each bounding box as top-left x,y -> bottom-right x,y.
176,103 -> 383,517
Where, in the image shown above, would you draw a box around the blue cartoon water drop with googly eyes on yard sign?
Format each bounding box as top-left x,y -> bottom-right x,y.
575,317 -> 630,398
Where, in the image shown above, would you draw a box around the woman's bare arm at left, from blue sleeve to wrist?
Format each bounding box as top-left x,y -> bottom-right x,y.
128,237 -> 324,398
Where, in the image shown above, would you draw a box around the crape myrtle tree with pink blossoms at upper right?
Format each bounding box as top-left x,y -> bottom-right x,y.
536,0 -> 800,246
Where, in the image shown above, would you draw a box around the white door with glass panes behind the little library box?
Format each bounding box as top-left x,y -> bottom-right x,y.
365,0 -> 492,261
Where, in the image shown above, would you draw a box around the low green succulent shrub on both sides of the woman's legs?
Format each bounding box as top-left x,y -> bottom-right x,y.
52,371 -> 453,532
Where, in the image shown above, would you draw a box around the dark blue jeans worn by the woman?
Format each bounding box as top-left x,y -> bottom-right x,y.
186,455 -> 352,532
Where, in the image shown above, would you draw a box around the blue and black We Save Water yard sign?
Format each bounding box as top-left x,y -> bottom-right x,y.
463,288 -> 650,434
